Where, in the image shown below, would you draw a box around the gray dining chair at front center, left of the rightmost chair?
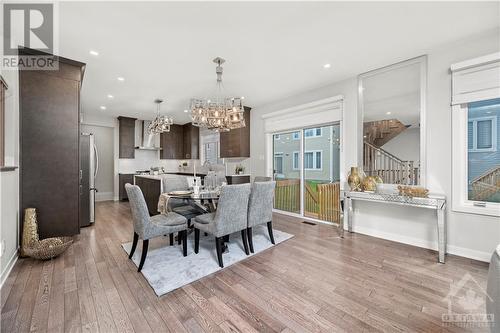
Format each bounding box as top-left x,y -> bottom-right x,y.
194,184 -> 250,267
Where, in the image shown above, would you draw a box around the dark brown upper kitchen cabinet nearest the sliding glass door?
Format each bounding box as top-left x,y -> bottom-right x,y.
220,106 -> 251,158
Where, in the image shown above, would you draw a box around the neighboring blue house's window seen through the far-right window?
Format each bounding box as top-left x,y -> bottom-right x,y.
467,115 -> 497,152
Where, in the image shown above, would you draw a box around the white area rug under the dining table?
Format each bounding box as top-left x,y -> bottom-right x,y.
122,225 -> 293,296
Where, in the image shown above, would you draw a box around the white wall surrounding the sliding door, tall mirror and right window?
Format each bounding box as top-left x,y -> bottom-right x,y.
247,30 -> 500,261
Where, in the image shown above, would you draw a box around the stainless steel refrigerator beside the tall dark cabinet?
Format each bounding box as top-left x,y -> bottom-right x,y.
80,133 -> 99,227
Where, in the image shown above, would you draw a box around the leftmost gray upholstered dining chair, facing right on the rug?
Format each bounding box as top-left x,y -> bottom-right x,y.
125,184 -> 187,272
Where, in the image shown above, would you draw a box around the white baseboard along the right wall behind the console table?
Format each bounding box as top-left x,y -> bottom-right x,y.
352,226 -> 491,262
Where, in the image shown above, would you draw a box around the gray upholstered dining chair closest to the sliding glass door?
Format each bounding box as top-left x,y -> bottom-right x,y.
247,181 -> 276,253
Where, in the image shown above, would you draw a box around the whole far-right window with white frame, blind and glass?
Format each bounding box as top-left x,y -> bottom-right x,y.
451,53 -> 500,216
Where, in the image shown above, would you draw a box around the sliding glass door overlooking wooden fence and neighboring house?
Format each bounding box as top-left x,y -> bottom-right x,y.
273,124 -> 340,222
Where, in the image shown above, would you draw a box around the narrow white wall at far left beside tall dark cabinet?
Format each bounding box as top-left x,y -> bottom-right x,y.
0,70 -> 19,285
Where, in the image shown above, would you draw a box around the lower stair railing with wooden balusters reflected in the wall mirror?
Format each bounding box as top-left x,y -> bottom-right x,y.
363,141 -> 420,185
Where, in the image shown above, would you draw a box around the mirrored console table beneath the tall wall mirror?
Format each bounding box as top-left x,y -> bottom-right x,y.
340,191 -> 446,263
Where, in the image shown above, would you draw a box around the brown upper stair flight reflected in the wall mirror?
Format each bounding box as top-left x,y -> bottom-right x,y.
363,119 -> 410,147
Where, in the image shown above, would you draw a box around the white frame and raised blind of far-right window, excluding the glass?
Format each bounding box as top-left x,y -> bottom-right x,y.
451,52 -> 500,217
